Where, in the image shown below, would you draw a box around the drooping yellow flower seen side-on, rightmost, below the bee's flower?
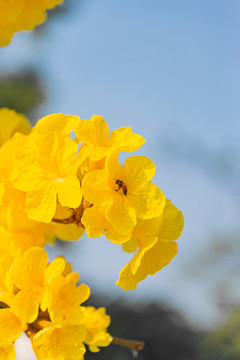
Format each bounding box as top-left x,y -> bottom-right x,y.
116,200 -> 184,290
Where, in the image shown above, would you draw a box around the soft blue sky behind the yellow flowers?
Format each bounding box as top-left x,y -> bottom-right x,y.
0,0 -> 240,325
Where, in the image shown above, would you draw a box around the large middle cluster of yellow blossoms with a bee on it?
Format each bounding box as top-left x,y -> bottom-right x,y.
0,109 -> 183,290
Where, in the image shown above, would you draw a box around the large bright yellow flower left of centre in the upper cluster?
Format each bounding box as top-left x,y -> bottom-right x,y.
5,132 -> 82,223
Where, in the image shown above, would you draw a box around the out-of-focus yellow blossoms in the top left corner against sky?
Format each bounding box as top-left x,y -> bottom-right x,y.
0,0 -> 63,46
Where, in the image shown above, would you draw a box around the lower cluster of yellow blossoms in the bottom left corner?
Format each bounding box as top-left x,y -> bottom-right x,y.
0,247 -> 112,360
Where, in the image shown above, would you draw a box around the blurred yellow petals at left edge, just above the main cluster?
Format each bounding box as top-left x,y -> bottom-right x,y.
0,107 -> 31,146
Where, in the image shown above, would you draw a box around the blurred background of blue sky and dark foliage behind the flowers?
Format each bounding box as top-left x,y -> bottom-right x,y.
0,0 -> 240,360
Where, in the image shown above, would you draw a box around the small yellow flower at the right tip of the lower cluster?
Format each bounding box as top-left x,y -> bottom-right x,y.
84,306 -> 112,352
